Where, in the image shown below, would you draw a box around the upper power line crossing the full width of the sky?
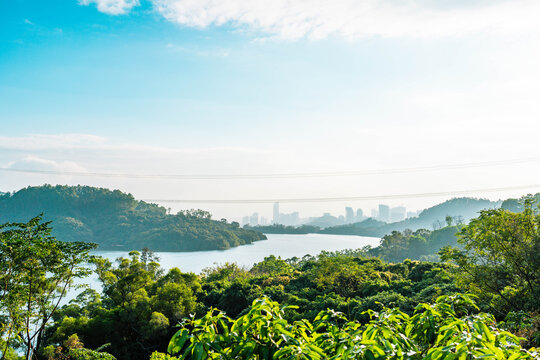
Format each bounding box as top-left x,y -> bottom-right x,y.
0,157 -> 540,180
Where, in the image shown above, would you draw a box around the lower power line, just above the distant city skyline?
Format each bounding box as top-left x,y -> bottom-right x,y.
144,184 -> 540,204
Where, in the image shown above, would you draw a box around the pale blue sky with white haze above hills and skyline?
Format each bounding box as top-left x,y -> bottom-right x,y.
0,0 -> 540,220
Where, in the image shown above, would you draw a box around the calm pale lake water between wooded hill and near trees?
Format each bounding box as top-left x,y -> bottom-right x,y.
66,234 -> 380,300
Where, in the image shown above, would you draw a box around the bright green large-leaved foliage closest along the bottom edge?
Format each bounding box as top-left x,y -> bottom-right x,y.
159,295 -> 538,360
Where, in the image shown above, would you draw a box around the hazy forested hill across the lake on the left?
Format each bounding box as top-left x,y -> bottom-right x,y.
0,185 -> 266,251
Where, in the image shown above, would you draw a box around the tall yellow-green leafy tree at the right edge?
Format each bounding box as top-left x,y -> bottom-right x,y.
440,197 -> 540,316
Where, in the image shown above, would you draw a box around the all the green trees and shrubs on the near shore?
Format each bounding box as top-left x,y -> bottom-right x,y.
0,198 -> 540,360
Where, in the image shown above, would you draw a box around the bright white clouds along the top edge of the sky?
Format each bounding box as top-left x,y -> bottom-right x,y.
81,0 -> 540,40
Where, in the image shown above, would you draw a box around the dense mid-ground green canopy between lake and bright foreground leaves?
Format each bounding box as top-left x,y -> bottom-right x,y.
199,250 -> 458,320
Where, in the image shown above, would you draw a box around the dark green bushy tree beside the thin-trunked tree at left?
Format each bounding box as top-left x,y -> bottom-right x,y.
45,250 -> 200,359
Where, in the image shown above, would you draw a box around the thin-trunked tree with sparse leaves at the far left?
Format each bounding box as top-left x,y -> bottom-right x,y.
0,215 -> 95,359
